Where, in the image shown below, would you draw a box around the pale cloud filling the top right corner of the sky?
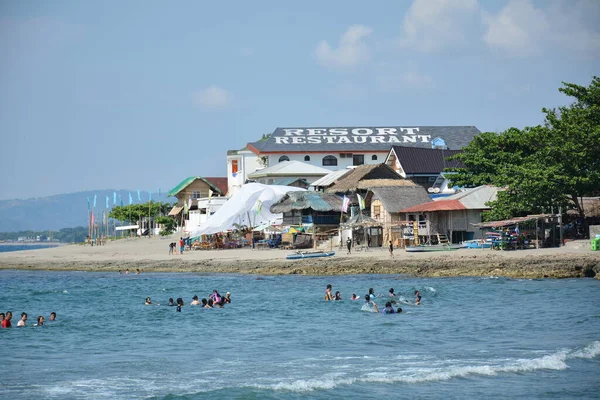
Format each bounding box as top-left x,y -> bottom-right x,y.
482,0 -> 600,57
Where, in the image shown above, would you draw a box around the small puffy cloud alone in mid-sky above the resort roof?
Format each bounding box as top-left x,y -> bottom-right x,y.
315,25 -> 372,69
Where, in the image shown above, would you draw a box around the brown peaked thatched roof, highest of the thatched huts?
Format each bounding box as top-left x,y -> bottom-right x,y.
326,163 -> 414,193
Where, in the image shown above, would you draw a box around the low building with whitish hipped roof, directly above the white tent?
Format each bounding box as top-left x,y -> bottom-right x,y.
248,161 -> 329,187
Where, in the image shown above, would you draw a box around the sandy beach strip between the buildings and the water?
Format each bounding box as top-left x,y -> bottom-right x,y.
0,237 -> 600,278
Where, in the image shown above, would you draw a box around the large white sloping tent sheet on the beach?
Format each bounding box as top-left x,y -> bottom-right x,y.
190,183 -> 305,237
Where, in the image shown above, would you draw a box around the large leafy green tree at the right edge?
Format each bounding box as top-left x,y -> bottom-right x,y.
451,77 -> 600,220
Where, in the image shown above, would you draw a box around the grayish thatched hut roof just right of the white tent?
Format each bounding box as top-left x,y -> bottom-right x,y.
271,191 -> 342,214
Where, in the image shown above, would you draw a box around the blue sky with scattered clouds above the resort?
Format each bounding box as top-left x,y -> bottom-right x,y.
0,0 -> 600,200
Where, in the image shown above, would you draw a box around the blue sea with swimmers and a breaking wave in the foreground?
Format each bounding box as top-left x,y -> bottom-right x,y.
0,270 -> 600,400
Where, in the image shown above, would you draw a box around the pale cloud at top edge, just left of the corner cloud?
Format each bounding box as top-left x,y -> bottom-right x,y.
398,0 -> 481,53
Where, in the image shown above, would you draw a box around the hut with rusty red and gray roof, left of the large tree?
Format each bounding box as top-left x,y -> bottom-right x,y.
400,185 -> 499,243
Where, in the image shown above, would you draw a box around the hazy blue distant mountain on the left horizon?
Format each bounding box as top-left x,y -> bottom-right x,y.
0,189 -> 171,232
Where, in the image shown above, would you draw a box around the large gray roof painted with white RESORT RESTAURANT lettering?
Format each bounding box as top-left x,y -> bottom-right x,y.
248,126 -> 481,153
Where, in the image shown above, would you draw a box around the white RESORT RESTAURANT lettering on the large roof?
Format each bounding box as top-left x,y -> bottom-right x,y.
273,127 -> 431,145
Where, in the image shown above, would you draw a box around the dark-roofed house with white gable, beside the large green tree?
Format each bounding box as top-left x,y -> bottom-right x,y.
385,146 -> 465,189
